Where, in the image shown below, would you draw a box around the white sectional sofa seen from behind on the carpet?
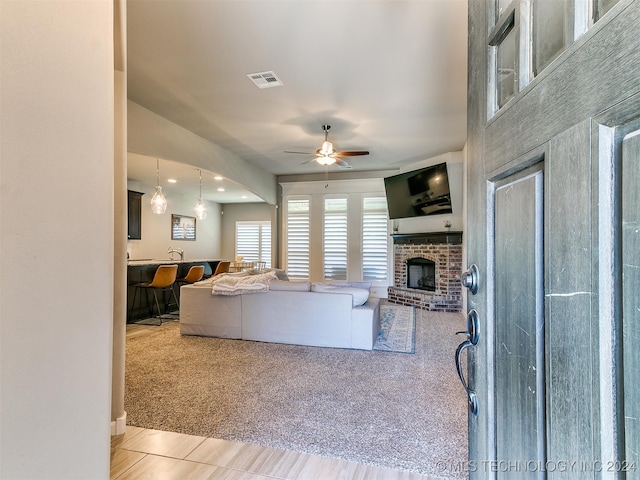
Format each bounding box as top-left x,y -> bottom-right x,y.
180,280 -> 380,350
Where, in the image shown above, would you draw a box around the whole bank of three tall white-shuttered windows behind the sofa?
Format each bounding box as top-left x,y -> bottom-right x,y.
281,178 -> 391,288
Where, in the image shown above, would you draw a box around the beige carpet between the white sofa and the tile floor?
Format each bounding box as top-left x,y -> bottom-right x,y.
125,310 -> 467,478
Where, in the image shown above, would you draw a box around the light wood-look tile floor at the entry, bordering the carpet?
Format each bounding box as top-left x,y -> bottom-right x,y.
111,426 -> 442,480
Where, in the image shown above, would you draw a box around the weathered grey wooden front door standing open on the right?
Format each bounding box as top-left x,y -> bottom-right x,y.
465,0 -> 640,480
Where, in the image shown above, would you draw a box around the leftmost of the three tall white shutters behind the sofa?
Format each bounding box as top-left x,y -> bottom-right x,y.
287,198 -> 310,280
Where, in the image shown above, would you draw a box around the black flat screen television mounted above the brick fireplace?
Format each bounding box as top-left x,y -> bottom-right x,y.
384,163 -> 453,219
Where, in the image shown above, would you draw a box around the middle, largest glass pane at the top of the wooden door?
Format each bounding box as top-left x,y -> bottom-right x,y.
533,0 -> 571,75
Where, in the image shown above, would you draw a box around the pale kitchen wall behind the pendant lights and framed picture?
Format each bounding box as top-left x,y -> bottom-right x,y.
127,182 -> 222,260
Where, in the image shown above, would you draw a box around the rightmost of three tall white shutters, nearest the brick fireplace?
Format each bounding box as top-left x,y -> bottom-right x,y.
362,197 -> 388,282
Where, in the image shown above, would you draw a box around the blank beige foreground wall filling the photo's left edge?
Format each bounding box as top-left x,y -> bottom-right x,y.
0,0 -> 114,480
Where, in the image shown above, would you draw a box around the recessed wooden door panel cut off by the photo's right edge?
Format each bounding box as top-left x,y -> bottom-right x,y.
621,131 -> 640,480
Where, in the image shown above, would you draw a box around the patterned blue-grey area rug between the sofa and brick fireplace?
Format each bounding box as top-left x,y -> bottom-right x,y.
373,303 -> 416,353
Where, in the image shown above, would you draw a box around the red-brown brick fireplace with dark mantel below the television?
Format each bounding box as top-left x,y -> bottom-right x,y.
387,232 -> 462,312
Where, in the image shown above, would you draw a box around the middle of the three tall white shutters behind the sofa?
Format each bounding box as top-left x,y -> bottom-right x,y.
324,198 -> 347,280
